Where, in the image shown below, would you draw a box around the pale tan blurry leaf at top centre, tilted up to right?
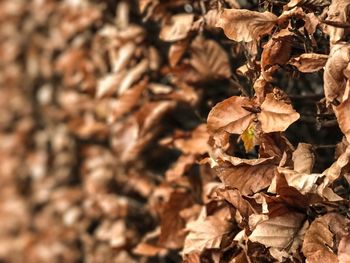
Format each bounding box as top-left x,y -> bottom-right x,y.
159,14 -> 194,42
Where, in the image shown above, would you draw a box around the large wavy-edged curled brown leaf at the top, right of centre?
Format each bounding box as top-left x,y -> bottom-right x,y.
216,9 -> 277,42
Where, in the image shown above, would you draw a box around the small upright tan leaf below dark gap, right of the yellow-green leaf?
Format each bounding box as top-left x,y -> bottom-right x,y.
292,143 -> 315,174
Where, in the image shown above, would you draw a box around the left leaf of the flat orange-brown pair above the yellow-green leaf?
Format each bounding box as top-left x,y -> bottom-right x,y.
207,96 -> 255,134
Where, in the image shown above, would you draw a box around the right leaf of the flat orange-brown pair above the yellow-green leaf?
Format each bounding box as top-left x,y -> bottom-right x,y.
258,94 -> 300,133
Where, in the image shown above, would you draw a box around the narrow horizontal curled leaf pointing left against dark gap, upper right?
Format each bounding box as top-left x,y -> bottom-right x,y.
288,53 -> 328,73
